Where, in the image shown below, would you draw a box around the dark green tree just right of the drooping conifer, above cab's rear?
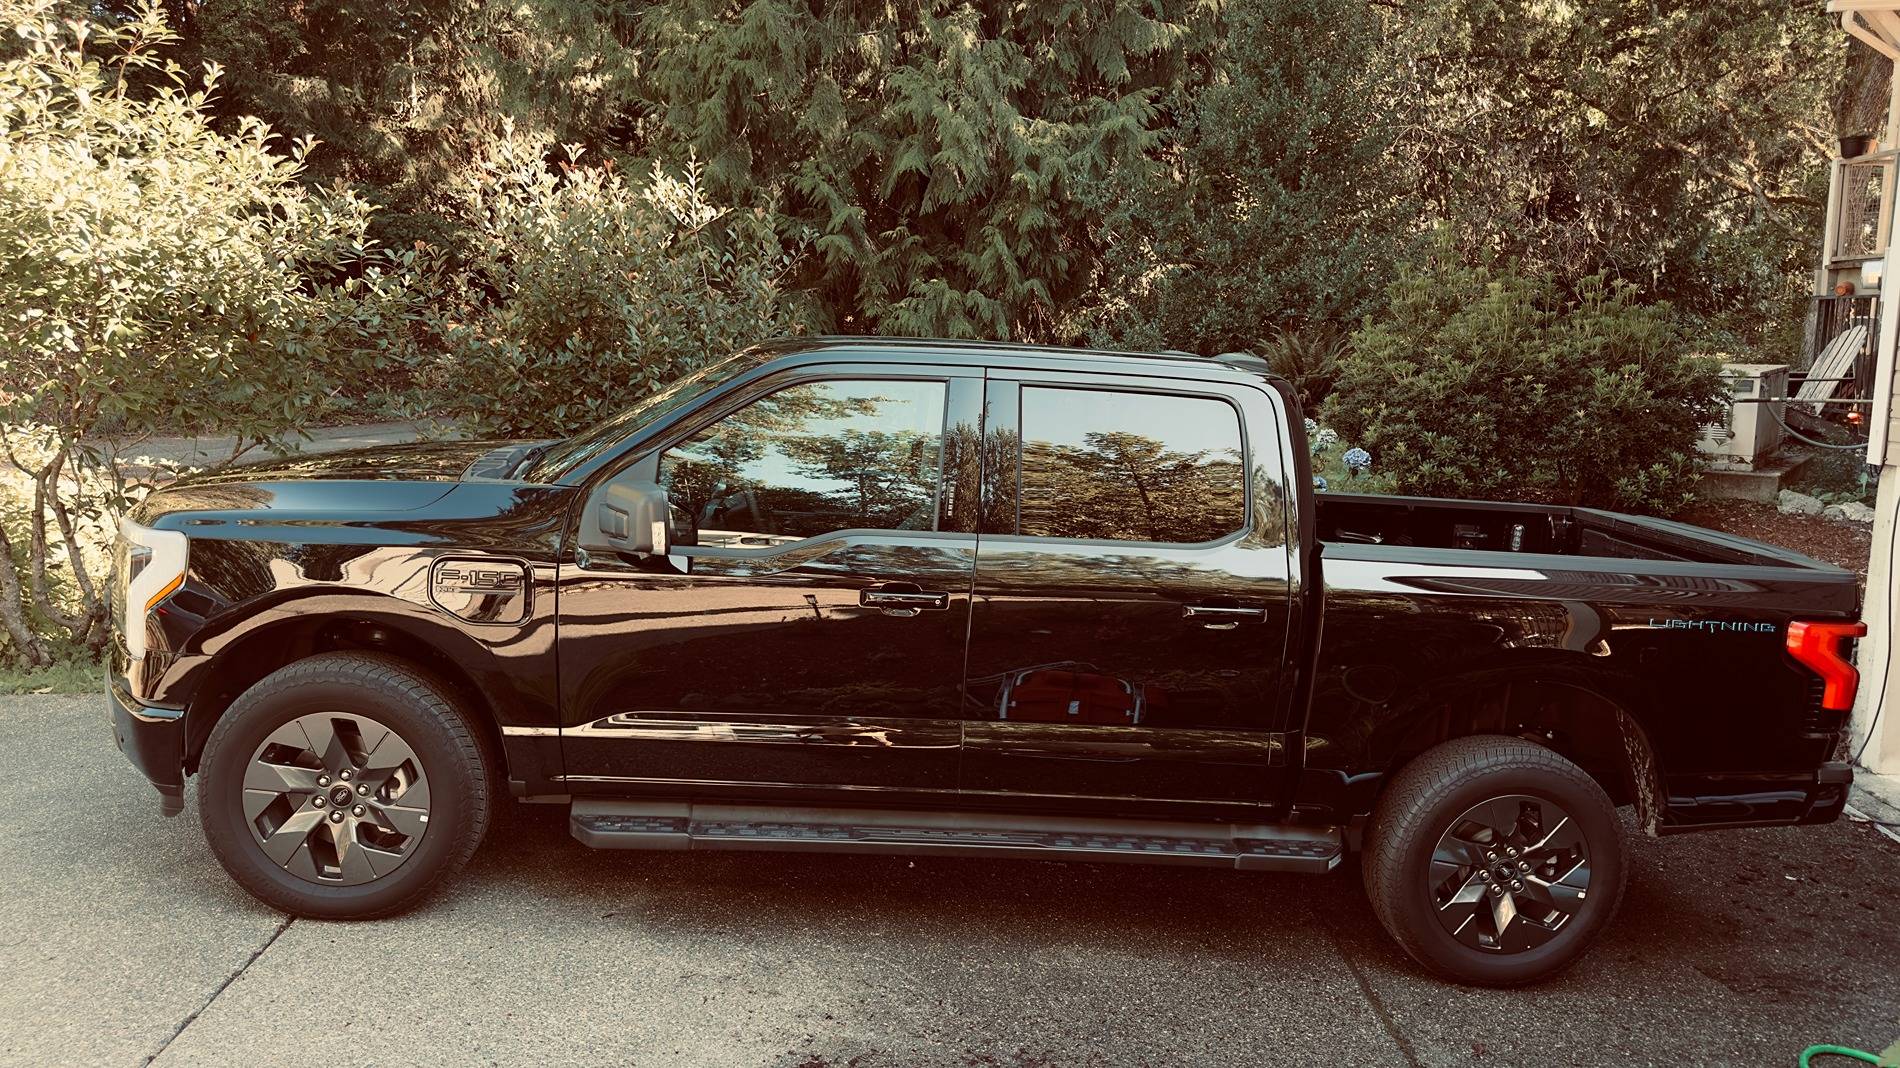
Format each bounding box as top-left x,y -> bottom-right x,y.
1098,0 -> 1417,353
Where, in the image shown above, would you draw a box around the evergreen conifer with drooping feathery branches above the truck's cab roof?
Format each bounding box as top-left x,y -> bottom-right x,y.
623,0 -> 1214,338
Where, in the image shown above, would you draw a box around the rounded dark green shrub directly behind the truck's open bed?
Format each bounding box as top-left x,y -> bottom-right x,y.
1326,249 -> 1720,513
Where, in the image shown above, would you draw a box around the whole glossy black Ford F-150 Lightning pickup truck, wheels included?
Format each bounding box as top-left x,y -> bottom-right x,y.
108,338 -> 1862,984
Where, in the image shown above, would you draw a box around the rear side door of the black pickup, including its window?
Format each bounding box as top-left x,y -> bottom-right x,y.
961,371 -> 1290,811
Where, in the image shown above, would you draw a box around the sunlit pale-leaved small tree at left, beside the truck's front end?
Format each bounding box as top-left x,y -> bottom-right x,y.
0,0 -> 393,665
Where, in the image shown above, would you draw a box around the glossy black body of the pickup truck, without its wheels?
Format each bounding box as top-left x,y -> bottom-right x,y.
110,338 -> 1856,972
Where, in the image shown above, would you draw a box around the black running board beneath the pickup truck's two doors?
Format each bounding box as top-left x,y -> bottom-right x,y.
568,798 -> 1341,874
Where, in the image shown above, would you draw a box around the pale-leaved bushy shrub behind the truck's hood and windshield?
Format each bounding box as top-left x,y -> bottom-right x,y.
424,129 -> 804,437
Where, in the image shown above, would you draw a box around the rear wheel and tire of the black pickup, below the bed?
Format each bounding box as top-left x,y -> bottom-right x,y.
1362,735 -> 1628,986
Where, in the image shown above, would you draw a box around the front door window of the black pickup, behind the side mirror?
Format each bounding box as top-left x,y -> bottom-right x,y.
659,382 -> 944,545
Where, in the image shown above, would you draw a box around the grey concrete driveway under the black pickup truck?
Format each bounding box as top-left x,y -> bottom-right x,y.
0,697 -> 1900,1068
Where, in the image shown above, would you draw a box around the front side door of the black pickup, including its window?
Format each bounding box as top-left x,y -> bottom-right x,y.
561,369 -> 982,798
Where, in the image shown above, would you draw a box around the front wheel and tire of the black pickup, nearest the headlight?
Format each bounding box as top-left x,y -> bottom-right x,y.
198,652 -> 498,920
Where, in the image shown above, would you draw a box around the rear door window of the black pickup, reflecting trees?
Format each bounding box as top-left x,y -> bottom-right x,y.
1020,388 -> 1246,544
